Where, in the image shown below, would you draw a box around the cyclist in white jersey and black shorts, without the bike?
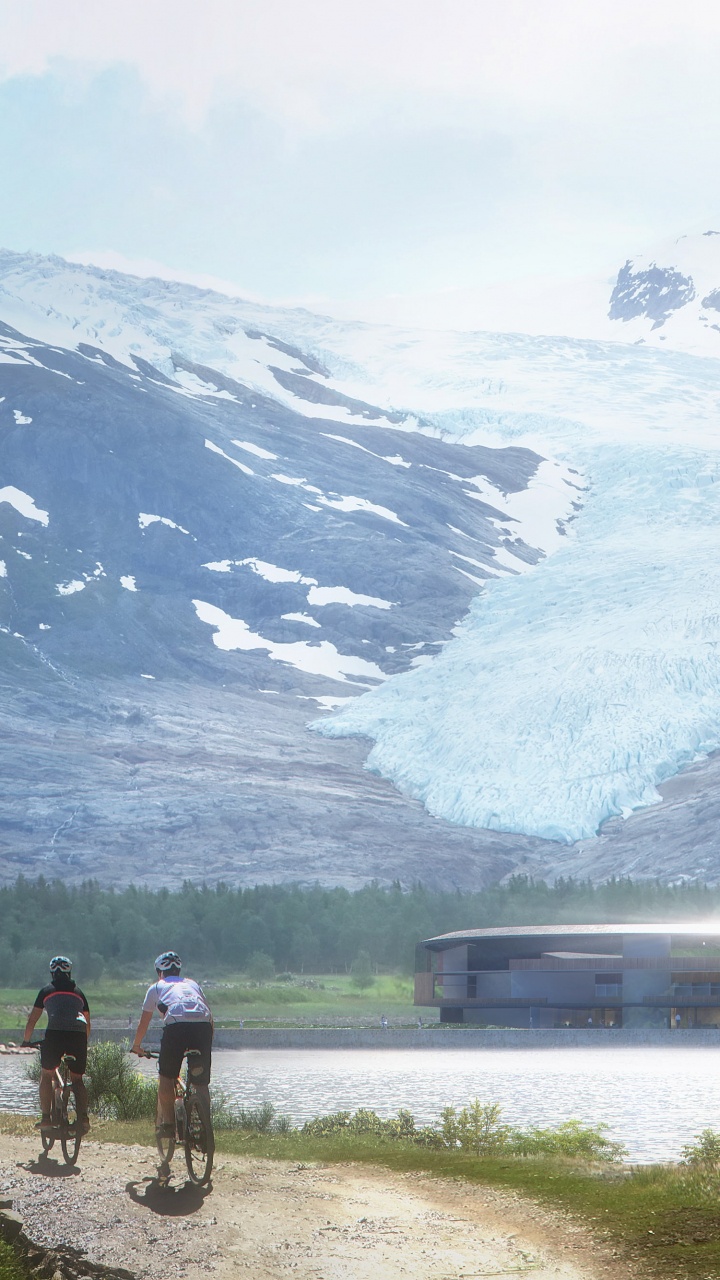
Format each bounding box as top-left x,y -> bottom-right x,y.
131,951 -> 214,1137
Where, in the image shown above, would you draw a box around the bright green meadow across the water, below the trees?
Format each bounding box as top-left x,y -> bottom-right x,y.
0,972 -> 417,1030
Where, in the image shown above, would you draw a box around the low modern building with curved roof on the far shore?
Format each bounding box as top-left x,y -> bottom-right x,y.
415,920 -> 720,1029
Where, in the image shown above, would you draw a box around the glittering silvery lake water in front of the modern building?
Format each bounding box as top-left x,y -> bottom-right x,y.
0,1048 -> 720,1161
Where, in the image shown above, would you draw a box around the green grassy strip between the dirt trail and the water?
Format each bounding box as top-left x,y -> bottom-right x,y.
0,1115 -> 720,1280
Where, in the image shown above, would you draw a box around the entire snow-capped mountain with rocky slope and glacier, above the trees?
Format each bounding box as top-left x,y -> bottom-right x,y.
0,247 -> 720,884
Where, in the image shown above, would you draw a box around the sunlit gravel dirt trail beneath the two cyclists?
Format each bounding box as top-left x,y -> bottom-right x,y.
0,1135 -> 630,1280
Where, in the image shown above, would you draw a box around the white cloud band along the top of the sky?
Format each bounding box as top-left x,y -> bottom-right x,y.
0,0 -> 720,132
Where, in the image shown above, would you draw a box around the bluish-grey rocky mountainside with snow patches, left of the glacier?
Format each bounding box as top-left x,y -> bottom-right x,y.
0,267 -> 578,884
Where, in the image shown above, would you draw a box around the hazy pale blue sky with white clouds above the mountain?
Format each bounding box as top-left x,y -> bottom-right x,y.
0,0 -> 720,319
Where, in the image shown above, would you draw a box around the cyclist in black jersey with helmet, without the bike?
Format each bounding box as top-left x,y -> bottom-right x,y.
23,956 -> 90,1133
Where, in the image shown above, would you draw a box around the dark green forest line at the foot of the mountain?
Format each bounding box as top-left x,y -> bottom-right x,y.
0,876 -> 720,987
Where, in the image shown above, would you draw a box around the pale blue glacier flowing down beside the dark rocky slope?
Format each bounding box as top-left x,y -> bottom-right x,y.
314,334 -> 720,844
